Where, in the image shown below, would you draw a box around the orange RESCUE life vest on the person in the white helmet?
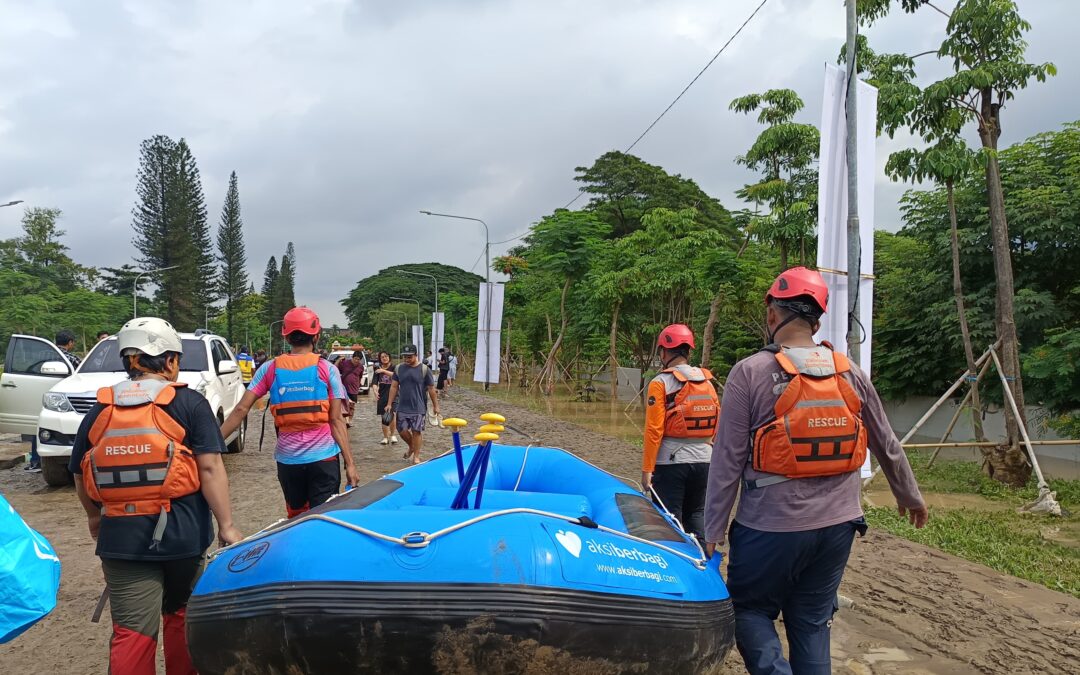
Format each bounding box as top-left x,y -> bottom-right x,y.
82,379 -> 200,527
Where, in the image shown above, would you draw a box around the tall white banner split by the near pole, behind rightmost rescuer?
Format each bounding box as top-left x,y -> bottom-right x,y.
815,60 -> 877,477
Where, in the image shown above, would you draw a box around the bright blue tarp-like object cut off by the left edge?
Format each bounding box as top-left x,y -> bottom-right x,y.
0,495 -> 60,644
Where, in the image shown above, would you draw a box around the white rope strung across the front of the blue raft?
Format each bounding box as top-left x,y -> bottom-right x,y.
207,509 -> 707,569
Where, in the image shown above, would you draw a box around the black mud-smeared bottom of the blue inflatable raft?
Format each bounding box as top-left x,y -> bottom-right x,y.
187,583 -> 734,675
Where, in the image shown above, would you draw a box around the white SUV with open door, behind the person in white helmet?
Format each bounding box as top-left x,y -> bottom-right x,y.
0,330 -> 247,485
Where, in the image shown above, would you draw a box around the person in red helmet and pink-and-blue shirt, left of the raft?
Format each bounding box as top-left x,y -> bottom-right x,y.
221,307 -> 360,517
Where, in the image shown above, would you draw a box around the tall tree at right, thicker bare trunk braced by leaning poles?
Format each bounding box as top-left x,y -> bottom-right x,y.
861,0 -> 1056,484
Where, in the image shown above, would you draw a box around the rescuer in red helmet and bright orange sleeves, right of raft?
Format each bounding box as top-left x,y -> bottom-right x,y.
642,323 -> 720,543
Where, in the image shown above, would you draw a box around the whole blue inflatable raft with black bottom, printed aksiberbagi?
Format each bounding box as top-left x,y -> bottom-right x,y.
187,434 -> 734,675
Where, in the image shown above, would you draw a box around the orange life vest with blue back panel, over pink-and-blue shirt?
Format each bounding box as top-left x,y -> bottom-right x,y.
267,353 -> 330,431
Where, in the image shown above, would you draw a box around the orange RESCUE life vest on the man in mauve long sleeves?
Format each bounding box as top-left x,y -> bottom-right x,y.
751,351 -> 866,485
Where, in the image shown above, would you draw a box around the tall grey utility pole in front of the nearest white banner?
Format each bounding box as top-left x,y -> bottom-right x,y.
846,0 -> 862,365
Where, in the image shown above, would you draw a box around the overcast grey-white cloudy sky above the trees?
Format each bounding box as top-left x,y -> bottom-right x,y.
0,0 -> 1080,323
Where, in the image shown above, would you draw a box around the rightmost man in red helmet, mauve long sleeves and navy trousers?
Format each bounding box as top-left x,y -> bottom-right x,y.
705,267 -> 929,674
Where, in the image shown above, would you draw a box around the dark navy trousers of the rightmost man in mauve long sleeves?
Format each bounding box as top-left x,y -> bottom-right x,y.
728,518 -> 866,675
